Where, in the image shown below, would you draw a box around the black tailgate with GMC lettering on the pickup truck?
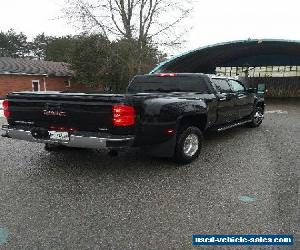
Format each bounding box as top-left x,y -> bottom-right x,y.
8,92 -> 125,132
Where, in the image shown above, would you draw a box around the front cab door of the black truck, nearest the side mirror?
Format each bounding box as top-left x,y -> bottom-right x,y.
229,80 -> 254,119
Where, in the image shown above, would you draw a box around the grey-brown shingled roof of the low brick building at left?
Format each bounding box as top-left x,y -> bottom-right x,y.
0,57 -> 74,76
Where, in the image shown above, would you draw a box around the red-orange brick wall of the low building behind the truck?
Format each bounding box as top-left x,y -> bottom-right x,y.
0,75 -> 95,99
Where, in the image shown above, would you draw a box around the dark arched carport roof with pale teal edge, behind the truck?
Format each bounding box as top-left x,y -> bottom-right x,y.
151,39 -> 300,73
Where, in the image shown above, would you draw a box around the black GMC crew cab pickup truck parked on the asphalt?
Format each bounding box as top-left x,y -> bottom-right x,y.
2,73 -> 264,163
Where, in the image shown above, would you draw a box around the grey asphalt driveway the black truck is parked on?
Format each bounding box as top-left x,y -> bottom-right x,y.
0,102 -> 300,249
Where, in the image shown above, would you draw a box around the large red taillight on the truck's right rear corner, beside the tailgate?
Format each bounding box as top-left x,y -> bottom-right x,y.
112,105 -> 135,127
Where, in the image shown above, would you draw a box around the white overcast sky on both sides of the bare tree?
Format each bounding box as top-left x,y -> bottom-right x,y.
0,0 -> 300,52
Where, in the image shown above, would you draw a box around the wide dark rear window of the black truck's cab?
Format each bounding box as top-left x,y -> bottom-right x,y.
127,75 -> 209,93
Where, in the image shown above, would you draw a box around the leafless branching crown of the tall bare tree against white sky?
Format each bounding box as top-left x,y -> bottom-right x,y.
64,0 -> 192,58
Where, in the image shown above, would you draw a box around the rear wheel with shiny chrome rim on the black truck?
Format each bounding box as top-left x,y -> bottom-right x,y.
175,126 -> 203,163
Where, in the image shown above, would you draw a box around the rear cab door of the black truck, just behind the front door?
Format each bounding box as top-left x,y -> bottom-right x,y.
211,78 -> 238,125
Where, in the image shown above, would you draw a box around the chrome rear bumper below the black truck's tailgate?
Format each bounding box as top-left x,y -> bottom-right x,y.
2,125 -> 135,149
